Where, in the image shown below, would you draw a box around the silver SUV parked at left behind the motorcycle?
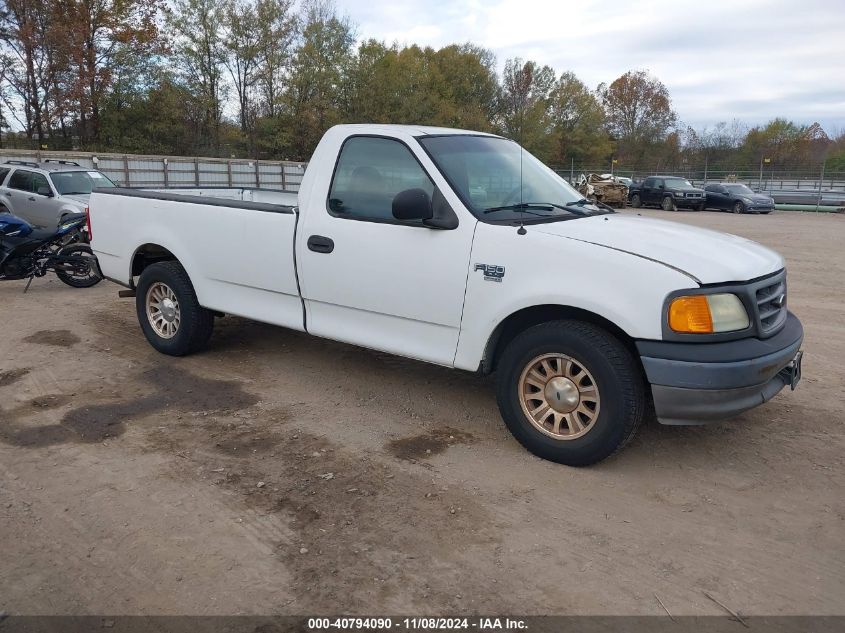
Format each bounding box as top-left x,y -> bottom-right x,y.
0,160 -> 116,230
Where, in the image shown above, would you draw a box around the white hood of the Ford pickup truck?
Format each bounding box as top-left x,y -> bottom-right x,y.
528,214 -> 783,284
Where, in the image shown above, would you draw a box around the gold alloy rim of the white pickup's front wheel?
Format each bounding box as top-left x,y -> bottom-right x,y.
518,354 -> 601,440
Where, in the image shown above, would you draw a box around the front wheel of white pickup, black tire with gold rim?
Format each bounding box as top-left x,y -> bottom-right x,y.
496,320 -> 646,466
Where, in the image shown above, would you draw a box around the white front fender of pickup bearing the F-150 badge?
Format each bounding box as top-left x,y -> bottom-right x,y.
455,220 -> 695,371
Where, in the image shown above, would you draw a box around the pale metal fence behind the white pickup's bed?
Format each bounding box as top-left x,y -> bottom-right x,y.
0,149 -> 307,191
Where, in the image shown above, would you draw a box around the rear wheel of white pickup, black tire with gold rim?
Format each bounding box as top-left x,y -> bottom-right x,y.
135,262 -> 214,356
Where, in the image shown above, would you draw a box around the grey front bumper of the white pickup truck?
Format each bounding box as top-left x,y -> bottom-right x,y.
637,312 -> 804,424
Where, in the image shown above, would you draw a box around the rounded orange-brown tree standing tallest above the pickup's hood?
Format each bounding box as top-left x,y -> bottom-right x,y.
598,70 -> 677,162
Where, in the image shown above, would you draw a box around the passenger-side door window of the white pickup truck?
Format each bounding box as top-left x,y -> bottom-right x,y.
329,136 -> 434,221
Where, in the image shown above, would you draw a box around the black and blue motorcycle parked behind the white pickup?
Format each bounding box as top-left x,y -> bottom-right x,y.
0,213 -> 102,292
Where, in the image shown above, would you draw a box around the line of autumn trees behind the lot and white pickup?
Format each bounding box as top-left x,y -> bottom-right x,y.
0,0 -> 845,170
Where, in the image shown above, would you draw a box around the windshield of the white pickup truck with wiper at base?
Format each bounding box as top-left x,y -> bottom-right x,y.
417,135 -> 608,222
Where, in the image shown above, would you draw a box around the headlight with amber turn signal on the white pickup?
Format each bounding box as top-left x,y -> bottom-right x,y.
669,293 -> 750,334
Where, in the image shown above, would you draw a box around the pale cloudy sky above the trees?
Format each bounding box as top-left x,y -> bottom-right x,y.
337,0 -> 845,134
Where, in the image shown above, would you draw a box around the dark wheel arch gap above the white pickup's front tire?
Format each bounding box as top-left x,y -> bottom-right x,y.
479,304 -> 640,374
